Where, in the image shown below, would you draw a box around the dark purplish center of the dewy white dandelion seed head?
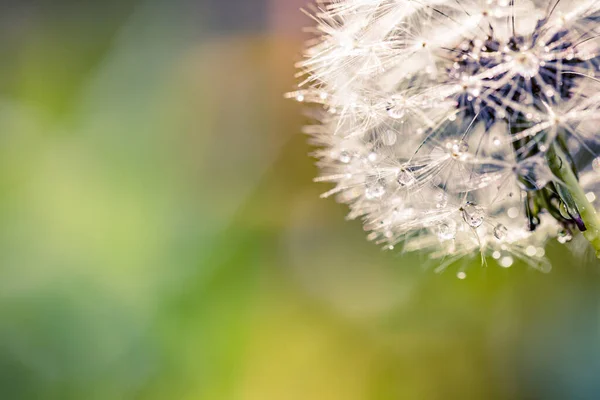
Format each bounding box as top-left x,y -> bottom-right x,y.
448,20 -> 598,127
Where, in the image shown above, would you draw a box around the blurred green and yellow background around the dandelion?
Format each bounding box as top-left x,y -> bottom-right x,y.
0,0 -> 600,400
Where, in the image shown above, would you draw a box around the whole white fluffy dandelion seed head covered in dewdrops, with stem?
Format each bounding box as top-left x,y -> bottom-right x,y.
289,0 -> 600,269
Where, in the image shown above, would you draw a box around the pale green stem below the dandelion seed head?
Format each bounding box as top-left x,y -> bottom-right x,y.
547,144 -> 600,258
